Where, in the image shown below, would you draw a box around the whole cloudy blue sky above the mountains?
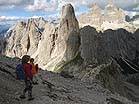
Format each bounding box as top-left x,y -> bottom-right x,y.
0,0 -> 139,23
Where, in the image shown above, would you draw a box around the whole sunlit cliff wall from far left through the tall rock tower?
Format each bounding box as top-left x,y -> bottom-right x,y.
5,4 -> 80,70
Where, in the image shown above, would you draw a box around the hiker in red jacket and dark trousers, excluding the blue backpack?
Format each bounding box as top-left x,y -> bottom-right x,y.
20,55 -> 33,100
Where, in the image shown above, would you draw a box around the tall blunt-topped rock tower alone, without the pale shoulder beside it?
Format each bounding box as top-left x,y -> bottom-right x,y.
55,4 -> 79,61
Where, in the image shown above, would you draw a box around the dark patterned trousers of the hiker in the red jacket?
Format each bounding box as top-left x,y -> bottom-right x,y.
23,79 -> 33,97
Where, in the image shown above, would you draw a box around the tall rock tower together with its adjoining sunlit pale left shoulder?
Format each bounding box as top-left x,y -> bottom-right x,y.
36,4 -> 80,70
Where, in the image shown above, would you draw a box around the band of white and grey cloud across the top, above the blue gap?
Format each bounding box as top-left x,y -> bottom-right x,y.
0,0 -> 139,11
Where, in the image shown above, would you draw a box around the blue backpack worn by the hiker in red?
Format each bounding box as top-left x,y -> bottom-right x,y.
16,64 -> 26,80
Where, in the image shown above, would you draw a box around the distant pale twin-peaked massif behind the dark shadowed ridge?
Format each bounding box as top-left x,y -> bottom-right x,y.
78,4 -> 139,32
